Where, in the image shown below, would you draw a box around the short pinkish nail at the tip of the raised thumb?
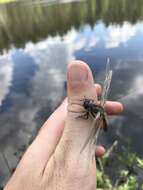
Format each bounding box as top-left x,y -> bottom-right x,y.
68,64 -> 88,84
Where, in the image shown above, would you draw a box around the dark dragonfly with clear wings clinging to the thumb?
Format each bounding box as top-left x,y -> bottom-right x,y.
82,58 -> 112,150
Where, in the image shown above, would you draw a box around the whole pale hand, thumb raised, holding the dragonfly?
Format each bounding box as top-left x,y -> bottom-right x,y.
4,61 -> 123,190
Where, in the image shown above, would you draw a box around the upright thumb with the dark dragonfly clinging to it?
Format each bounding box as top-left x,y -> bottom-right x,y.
57,61 -> 97,157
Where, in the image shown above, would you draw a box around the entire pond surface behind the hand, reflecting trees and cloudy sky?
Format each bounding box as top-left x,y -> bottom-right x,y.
0,0 -> 143,187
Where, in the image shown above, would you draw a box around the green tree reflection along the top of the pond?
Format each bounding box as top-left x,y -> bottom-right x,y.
0,0 -> 143,51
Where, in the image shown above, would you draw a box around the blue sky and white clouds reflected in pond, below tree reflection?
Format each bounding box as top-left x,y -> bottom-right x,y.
0,0 -> 143,186
